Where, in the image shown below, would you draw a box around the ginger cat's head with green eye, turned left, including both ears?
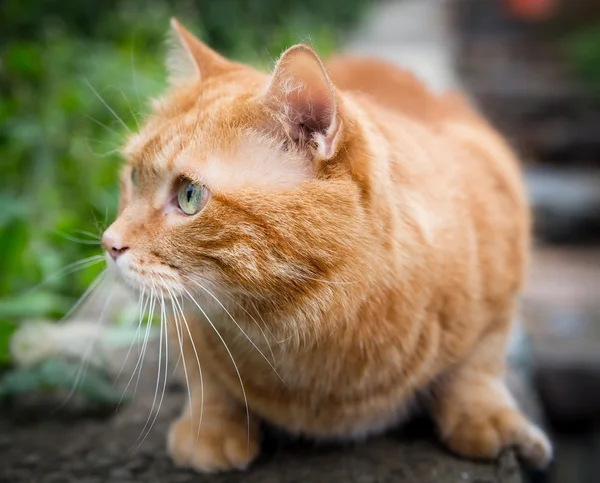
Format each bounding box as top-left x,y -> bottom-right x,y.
103,21 -> 366,318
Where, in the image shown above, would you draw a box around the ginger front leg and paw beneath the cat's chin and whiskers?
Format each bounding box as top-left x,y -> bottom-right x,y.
167,318 -> 260,473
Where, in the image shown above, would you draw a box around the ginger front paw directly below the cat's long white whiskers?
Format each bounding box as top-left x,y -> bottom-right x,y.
167,418 -> 260,473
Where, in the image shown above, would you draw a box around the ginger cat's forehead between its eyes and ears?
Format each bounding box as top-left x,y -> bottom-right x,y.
125,118 -> 314,192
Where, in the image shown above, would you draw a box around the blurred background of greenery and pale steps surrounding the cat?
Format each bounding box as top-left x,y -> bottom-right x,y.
0,0 -> 600,483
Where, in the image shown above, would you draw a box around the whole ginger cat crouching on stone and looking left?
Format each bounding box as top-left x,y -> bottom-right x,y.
103,21 -> 552,472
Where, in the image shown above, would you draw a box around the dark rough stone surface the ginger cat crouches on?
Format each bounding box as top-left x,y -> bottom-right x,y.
0,374 -> 521,483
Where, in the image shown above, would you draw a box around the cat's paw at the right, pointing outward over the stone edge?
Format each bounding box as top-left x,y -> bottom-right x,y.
445,408 -> 552,468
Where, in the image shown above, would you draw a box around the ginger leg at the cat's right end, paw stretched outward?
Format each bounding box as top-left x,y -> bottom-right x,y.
433,326 -> 552,468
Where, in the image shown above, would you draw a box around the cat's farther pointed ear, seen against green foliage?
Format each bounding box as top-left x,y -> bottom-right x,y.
167,18 -> 234,85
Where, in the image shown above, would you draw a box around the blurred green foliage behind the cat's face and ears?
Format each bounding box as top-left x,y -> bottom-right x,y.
0,0 -> 368,364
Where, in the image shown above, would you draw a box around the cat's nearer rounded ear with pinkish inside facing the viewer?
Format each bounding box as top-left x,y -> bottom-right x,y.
266,44 -> 342,160
